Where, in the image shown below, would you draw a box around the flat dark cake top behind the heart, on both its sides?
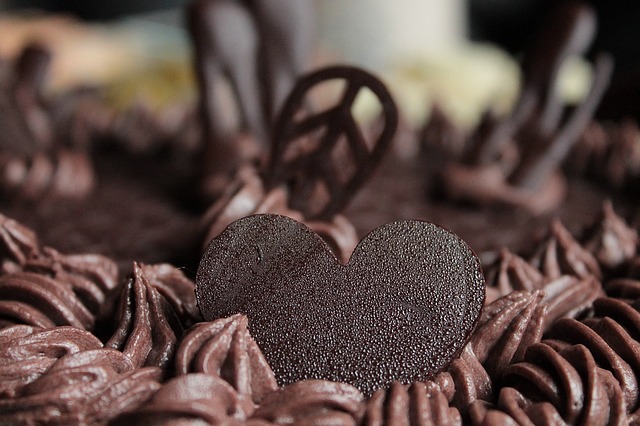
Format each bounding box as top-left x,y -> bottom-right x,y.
0,136 -> 640,275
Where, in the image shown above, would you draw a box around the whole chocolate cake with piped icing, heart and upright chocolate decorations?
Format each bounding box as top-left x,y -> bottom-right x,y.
0,0 -> 640,425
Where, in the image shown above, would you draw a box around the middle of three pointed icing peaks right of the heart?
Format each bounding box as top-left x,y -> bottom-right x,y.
531,220 -> 602,279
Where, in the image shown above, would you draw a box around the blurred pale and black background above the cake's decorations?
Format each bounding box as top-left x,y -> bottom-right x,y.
0,0 -> 640,123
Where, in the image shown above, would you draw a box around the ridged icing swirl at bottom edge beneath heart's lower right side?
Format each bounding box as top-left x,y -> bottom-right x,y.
364,382 -> 462,426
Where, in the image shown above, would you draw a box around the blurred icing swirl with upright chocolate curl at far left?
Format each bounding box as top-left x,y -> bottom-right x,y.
0,44 -> 94,200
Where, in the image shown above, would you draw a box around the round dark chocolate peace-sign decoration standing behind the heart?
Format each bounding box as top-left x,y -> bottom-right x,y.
267,66 -> 398,219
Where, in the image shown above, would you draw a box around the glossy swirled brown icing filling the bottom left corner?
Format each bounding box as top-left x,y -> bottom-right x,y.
0,326 -> 160,424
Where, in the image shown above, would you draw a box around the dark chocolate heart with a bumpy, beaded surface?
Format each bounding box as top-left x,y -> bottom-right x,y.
196,214 -> 485,394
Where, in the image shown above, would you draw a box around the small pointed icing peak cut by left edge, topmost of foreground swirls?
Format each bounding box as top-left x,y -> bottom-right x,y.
0,214 -> 40,273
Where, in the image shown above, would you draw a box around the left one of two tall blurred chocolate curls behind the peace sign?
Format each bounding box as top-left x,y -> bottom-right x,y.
187,0 -> 267,195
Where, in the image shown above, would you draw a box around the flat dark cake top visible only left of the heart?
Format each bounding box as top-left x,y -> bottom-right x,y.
0,146 -> 201,268
